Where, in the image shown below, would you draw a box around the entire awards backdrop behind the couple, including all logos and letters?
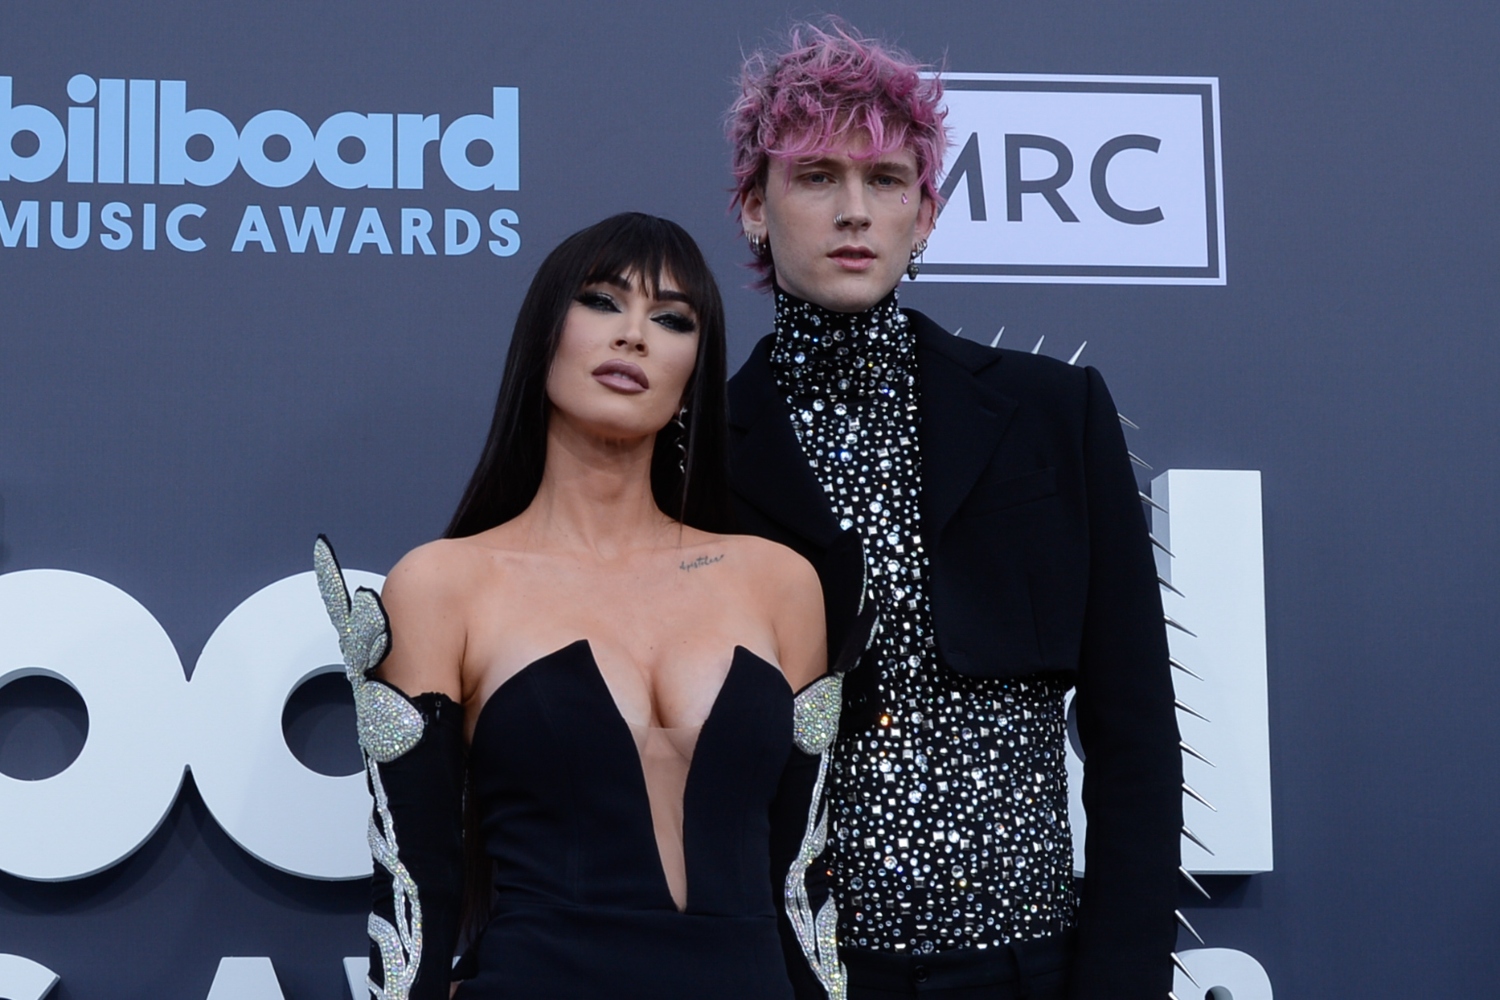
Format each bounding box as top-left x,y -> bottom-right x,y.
0,0 -> 1500,1000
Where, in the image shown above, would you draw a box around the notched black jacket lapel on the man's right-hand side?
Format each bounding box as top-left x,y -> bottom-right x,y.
906,310 -> 1016,550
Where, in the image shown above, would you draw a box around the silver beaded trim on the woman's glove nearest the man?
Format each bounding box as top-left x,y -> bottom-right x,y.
786,673 -> 849,1000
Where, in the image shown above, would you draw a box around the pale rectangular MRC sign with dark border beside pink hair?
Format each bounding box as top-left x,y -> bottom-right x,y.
920,73 -> 1226,285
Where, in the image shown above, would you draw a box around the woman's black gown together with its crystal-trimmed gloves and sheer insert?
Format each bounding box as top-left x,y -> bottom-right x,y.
315,538 -> 873,1000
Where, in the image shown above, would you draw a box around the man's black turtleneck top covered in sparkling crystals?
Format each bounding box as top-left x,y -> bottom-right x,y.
771,289 -> 1077,954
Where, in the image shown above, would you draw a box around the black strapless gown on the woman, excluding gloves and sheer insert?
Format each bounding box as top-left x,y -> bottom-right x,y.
458,640 -> 807,1000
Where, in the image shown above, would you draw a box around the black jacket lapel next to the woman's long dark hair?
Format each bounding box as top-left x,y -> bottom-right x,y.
729,337 -> 839,549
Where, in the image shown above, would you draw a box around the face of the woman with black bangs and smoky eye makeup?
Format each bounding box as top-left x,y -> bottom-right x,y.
548,274 -> 699,439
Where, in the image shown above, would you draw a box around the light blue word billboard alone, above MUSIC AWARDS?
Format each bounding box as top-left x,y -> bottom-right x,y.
0,73 -> 521,190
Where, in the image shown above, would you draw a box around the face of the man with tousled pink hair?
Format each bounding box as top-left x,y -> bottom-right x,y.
741,138 -> 936,312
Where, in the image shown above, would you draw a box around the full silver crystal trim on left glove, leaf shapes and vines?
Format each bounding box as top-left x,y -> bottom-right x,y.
312,538 -> 426,1000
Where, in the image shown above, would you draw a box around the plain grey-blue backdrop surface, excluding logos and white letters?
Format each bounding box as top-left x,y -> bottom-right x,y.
0,0 -> 1500,1000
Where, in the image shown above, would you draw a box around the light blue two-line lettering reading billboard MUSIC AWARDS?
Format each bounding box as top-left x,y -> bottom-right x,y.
0,73 -> 521,256
